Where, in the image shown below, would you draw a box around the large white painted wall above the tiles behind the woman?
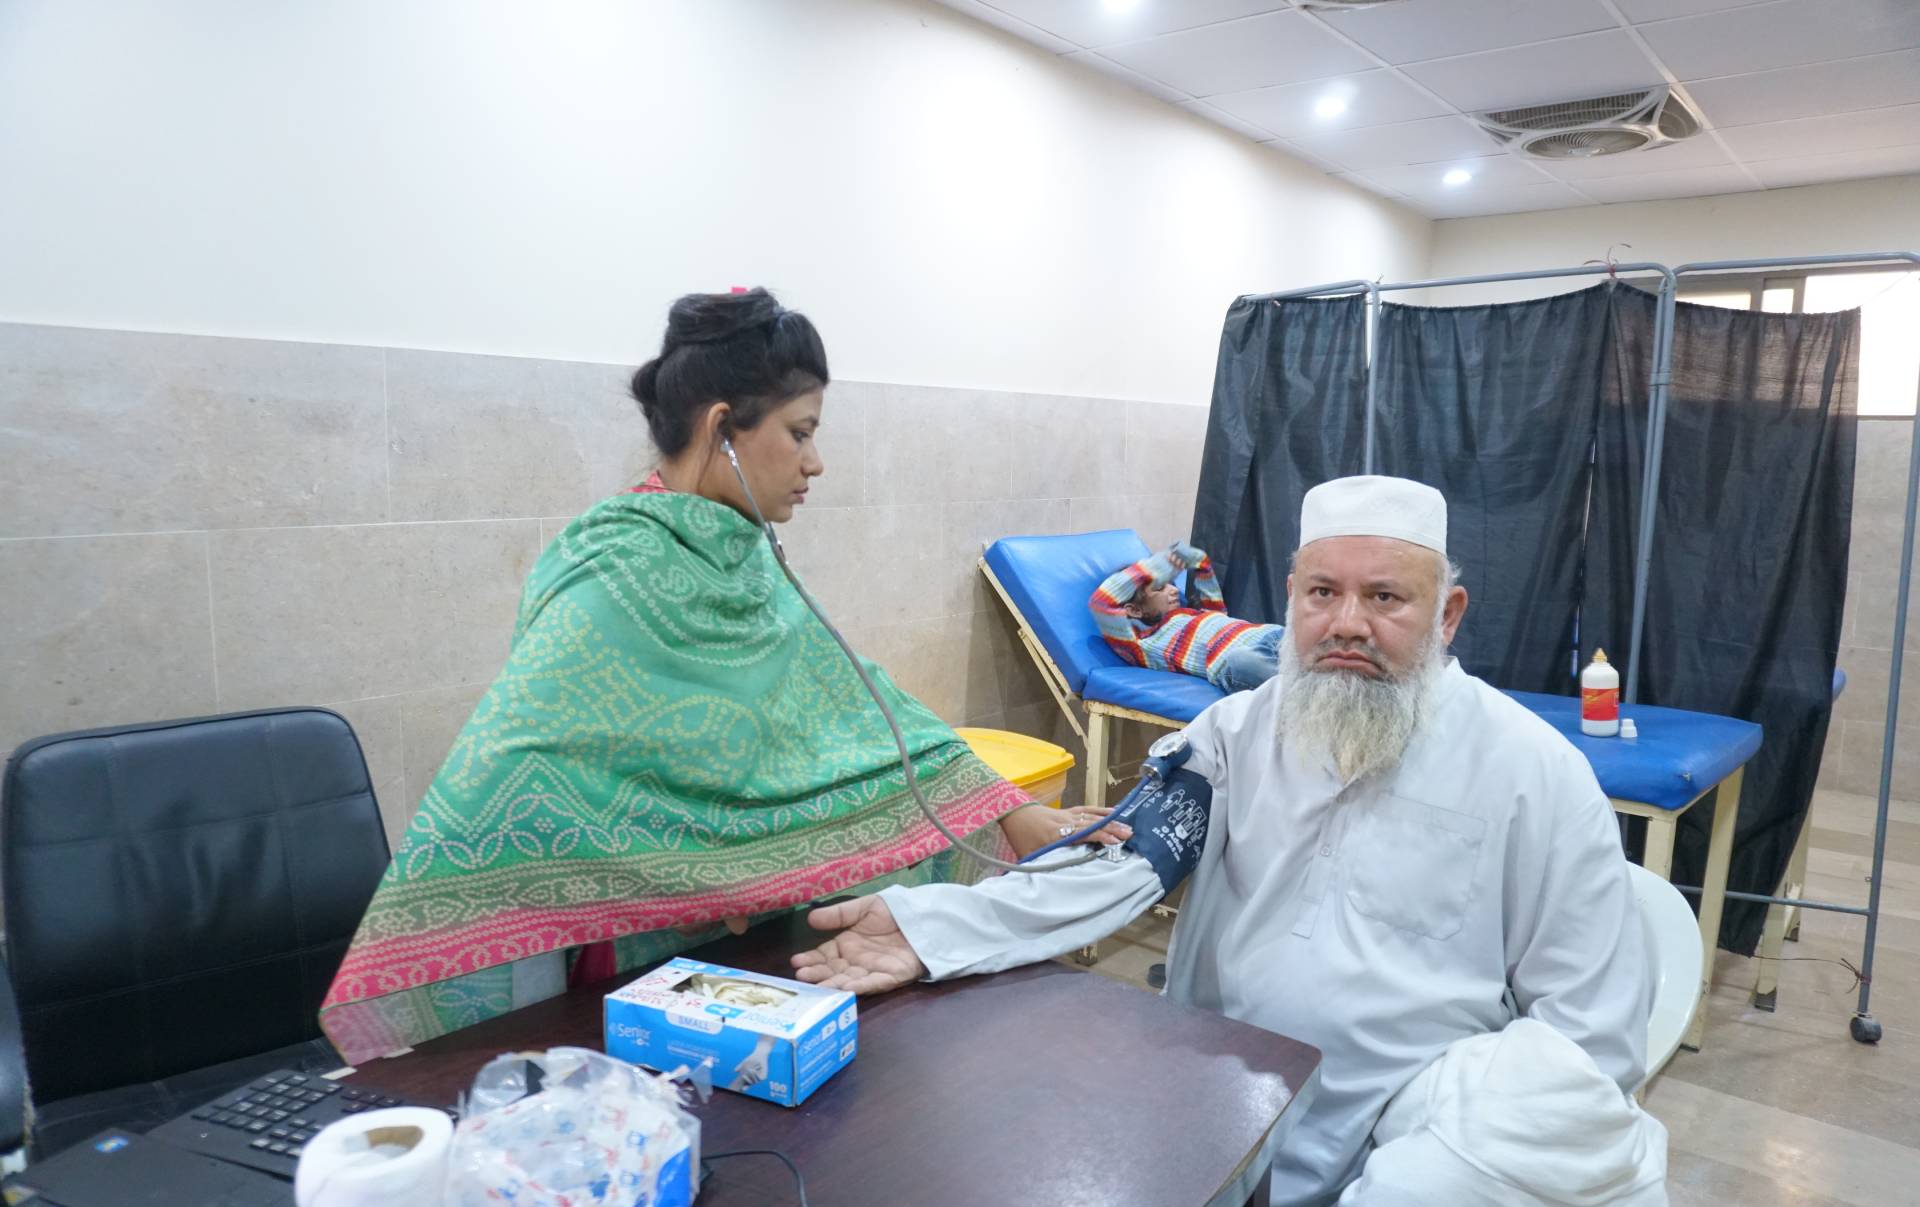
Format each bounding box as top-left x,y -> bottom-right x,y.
0,0 -> 1432,401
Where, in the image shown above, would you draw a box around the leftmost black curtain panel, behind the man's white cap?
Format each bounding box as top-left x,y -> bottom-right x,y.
1192,296 -> 1367,624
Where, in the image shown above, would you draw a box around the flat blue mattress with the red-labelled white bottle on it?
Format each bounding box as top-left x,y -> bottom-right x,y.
1507,691 -> 1761,810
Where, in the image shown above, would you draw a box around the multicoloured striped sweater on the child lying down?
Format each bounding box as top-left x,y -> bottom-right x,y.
1087,549 -> 1265,679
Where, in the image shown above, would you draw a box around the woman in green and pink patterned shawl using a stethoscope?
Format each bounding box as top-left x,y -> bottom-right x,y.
321,290 -> 1125,1063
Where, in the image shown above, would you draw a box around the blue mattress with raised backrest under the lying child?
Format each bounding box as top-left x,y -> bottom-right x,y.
987,528 -> 1225,722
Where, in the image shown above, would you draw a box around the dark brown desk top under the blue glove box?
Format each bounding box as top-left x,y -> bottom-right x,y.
351,915 -> 1321,1207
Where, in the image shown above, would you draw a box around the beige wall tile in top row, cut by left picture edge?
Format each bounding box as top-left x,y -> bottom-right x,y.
0,324 -> 386,535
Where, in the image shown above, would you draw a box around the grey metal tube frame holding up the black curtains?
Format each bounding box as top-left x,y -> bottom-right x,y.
1248,251 -> 1920,1044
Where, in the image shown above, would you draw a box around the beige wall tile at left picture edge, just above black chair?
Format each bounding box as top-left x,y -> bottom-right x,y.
0,532 -> 217,750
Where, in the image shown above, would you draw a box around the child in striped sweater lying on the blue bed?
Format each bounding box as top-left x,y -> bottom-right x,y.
1087,541 -> 1284,691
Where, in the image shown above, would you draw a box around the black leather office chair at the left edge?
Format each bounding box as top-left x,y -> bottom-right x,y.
0,708 -> 388,1157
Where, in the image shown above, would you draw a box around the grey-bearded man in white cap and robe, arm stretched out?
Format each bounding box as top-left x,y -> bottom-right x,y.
793,476 -> 1667,1205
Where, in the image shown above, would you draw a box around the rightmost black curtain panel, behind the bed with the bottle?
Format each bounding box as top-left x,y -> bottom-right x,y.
1580,288 -> 1860,954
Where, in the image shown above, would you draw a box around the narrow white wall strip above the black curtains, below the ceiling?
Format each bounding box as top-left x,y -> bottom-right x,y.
1428,177 -> 1920,305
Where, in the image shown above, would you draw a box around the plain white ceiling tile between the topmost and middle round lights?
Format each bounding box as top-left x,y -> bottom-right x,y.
1102,12 -> 1375,96
